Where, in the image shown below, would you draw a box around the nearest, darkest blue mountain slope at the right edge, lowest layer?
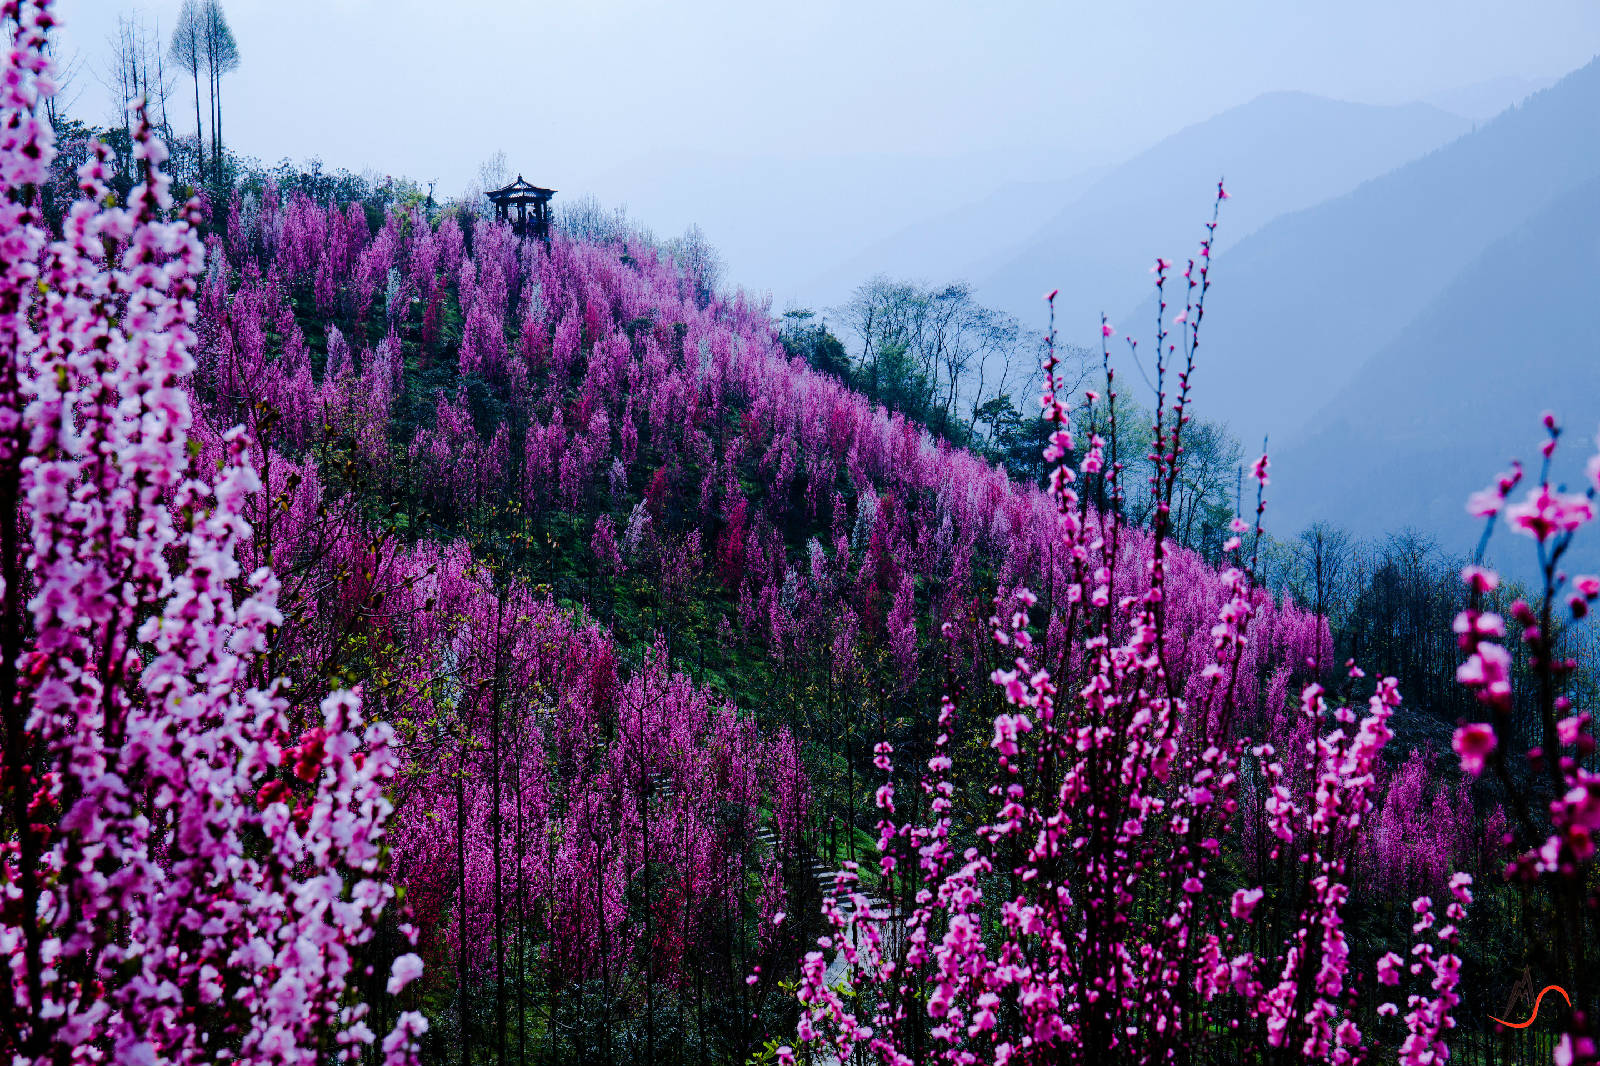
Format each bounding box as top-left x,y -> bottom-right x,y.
1272,168 -> 1600,559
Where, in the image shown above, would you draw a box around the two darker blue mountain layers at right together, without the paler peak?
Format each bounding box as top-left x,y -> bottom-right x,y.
1100,61 -> 1600,547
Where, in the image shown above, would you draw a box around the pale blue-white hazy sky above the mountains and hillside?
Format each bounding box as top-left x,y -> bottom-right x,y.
58,0 -> 1600,299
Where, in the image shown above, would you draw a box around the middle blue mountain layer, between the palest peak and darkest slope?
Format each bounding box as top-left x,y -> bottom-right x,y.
1128,61 -> 1600,463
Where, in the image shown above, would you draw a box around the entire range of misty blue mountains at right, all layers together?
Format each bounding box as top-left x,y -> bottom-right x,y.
681,62 -> 1600,560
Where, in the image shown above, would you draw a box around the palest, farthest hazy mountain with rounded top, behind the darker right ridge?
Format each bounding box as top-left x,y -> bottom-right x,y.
974,93 -> 1470,336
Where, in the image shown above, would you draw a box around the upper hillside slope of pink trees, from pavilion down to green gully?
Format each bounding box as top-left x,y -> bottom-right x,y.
202,192 -> 1322,760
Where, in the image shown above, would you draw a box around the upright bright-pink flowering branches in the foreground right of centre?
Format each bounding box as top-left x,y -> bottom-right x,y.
798,222 -> 1448,1064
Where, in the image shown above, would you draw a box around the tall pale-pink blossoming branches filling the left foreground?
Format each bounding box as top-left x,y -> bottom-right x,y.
0,2 -> 426,1064
